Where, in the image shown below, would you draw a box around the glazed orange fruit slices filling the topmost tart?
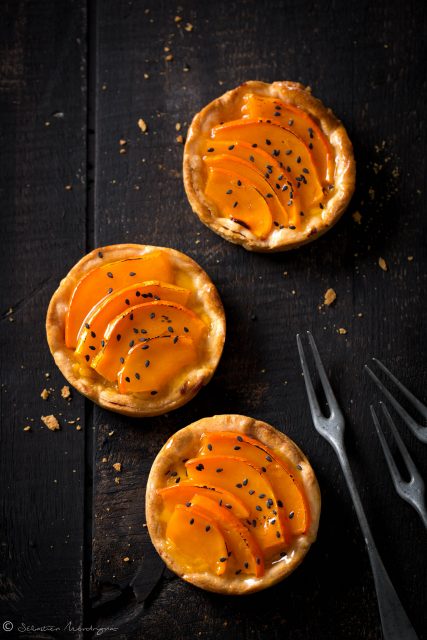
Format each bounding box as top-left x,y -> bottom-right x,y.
201,94 -> 334,239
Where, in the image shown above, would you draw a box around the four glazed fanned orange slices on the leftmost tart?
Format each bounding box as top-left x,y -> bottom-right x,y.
65,251 -> 208,396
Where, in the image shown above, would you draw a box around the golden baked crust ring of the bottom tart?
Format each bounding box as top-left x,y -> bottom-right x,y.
146,414 -> 321,595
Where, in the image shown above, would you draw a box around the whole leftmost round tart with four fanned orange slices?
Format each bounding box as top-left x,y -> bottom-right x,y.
46,244 -> 225,417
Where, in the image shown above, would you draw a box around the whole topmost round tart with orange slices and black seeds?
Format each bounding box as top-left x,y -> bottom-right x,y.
183,81 -> 356,251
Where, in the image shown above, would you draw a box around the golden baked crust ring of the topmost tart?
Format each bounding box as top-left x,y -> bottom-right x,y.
183,81 -> 356,252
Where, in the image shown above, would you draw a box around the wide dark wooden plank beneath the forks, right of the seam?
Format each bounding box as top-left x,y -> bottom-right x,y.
92,1 -> 427,640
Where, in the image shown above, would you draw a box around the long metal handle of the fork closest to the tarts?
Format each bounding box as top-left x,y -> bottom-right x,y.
336,448 -> 418,640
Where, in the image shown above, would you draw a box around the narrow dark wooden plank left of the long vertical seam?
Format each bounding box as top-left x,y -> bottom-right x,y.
0,1 -> 86,637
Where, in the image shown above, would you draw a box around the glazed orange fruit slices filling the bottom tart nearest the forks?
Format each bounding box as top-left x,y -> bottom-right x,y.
157,431 -> 309,577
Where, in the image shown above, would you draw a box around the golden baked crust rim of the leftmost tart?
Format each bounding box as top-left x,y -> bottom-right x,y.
46,244 -> 225,417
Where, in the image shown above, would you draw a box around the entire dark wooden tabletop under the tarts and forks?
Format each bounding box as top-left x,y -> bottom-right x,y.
0,0 -> 427,640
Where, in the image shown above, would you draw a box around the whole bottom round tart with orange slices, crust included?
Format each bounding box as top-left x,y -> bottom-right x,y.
146,415 -> 320,595
